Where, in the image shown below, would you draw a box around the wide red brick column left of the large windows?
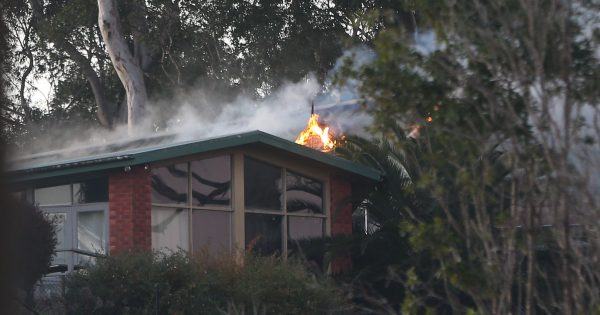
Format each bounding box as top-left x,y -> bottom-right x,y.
108,166 -> 152,254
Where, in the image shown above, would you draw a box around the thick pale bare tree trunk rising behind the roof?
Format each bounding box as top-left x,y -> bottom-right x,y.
98,0 -> 147,134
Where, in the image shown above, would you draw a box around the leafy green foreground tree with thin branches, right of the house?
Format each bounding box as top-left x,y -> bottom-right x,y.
340,0 -> 600,314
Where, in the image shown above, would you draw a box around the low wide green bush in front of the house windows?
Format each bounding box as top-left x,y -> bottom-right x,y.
65,251 -> 342,314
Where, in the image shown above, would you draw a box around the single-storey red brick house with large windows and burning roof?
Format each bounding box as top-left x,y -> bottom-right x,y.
9,131 -> 380,271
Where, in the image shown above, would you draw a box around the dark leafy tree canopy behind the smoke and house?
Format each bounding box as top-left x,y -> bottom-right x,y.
2,0 -> 414,141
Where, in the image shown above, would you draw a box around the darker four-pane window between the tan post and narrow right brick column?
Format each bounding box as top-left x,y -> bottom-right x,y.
244,157 -> 326,255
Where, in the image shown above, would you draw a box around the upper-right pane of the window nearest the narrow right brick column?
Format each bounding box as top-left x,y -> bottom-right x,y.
285,172 -> 323,213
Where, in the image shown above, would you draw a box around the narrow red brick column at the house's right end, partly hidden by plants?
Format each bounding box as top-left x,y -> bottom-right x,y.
329,175 -> 352,274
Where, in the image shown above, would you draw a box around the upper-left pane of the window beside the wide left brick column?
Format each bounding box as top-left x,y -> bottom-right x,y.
152,163 -> 188,204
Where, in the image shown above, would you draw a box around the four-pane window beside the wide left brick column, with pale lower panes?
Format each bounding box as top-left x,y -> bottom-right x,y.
152,155 -> 233,253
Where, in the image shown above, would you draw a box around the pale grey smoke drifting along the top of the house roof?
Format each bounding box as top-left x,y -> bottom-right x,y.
10,47 -> 374,159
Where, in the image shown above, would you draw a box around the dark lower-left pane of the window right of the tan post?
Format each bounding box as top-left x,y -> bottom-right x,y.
245,213 -> 282,255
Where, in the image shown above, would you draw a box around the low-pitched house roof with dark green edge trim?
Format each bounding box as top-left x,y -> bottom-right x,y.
8,131 -> 381,182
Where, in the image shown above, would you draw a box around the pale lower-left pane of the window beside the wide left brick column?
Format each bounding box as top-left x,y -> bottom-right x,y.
152,207 -> 189,251
